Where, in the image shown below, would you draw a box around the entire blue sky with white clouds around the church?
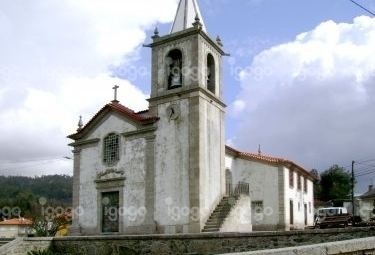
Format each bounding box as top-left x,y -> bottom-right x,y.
0,0 -> 375,191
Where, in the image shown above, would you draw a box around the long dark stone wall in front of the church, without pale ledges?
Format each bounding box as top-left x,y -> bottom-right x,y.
53,228 -> 375,255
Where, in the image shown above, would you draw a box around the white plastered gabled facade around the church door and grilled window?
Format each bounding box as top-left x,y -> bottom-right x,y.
79,113 -> 146,234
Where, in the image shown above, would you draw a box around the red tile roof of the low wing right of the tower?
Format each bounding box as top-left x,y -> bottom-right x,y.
225,146 -> 316,180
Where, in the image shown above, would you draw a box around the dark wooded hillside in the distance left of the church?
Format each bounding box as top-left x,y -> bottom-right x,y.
0,175 -> 73,218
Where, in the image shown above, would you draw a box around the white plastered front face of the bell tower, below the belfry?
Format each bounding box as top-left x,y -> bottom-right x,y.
155,99 -> 190,233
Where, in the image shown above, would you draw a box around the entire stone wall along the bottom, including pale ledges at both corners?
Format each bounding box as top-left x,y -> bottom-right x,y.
0,228 -> 375,255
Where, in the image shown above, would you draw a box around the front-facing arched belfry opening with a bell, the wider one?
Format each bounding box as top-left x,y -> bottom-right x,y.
166,49 -> 182,89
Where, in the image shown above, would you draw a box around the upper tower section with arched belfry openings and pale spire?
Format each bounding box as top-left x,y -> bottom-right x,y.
149,0 -> 225,101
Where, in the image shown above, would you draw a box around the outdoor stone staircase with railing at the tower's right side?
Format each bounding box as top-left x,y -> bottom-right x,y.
202,182 -> 249,232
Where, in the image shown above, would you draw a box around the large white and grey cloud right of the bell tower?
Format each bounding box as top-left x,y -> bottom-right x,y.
233,16 -> 375,175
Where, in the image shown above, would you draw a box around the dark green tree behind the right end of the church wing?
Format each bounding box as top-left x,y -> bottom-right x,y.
320,165 -> 352,201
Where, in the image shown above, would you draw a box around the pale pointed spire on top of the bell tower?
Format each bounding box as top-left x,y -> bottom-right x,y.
171,0 -> 206,34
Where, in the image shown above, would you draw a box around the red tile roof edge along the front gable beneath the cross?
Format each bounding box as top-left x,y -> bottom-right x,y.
68,102 -> 159,140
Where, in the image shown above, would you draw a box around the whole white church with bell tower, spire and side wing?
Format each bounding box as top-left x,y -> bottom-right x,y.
69,0 -> 314,235
